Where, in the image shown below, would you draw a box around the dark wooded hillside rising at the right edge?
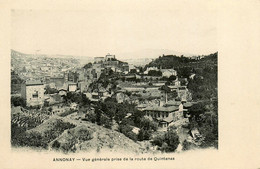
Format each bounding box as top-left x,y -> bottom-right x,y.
145,52 -> 218,100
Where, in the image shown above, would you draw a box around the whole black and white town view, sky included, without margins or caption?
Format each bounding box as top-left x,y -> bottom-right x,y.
11,6 -> 218,154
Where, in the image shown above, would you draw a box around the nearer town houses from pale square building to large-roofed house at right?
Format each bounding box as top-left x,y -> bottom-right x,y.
17,54 -> 194,131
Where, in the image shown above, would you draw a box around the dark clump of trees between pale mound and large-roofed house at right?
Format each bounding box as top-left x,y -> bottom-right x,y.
86,99 -> 158,141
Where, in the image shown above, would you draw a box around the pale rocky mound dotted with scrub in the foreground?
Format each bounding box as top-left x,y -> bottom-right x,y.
13,113 -> 155,154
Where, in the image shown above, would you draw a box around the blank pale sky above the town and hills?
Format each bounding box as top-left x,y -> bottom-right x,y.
11,1 -> 218,57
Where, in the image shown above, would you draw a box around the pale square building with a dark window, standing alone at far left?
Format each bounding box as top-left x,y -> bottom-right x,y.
21,81 -> 44,106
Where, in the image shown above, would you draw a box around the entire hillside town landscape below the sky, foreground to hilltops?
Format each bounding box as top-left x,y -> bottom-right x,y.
11,50 -> 218,154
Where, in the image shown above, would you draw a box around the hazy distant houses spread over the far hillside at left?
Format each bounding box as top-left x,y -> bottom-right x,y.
11,50 -> 80,81
